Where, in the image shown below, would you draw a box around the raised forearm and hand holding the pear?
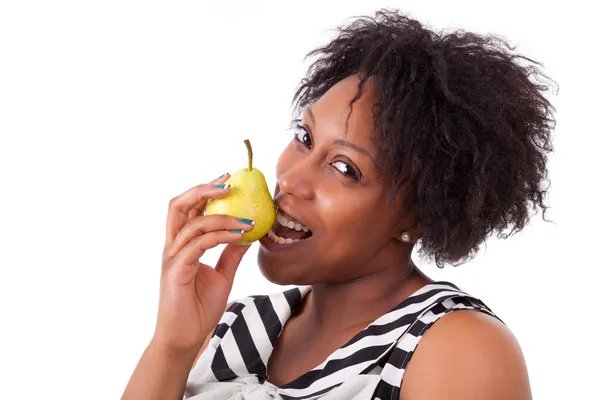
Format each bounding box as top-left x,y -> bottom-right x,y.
121,174 -> 254,400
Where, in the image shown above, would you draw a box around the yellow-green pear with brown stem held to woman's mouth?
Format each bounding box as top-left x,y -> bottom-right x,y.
204,139 -> 275,245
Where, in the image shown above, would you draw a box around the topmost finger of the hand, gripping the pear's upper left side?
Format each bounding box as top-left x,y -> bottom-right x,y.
165,174 -> 230,246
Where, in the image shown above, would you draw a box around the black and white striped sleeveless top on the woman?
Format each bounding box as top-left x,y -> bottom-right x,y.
184,282 -> 494,400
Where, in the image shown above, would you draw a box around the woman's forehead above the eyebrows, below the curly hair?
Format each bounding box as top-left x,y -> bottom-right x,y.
304,75 -> 378,148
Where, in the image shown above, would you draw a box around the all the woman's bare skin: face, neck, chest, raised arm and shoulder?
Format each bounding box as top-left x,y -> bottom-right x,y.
122,76 -> 531,400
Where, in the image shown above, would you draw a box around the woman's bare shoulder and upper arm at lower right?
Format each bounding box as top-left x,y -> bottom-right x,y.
400,310 -> 531,400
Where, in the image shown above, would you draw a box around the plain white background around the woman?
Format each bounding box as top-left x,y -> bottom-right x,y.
0,0 -> 600,399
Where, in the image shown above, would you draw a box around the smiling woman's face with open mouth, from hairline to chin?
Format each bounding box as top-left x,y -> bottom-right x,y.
258,76 -> 409,285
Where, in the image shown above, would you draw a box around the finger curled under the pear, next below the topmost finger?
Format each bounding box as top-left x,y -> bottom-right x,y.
164,215 -> 254,259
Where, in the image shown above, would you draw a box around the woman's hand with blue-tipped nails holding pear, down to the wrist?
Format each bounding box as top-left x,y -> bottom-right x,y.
152,174 -> 253,351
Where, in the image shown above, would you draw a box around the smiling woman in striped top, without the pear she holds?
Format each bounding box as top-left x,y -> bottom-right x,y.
123,11 -> 553,400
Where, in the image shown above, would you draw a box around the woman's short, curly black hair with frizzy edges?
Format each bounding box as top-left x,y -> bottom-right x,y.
293,9 -> 555,268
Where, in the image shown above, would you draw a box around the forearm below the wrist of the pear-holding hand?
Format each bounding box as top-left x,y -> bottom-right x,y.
121,342 -> 200,400
